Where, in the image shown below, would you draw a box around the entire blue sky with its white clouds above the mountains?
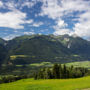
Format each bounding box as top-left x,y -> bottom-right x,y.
0,0 -> 90,40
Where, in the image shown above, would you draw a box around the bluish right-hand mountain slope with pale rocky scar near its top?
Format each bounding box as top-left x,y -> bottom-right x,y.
52,35 -> 90,56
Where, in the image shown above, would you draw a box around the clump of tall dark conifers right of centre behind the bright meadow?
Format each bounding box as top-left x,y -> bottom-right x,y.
34,64 -> 88,79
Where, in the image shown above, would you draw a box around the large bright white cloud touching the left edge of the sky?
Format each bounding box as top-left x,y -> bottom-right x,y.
0,10 -> 33,29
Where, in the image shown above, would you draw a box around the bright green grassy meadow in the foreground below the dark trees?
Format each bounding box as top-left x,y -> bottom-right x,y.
0,76 -> 90,90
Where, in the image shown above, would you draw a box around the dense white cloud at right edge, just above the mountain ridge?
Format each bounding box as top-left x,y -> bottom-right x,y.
73,11 -> 90,38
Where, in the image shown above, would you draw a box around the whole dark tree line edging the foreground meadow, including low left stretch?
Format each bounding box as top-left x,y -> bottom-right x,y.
0,64 -> 90,83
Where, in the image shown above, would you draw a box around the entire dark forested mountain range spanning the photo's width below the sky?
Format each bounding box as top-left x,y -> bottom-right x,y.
0,35 -> 90,65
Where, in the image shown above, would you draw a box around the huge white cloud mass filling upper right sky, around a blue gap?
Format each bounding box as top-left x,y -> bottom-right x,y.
39,0 -> 90,37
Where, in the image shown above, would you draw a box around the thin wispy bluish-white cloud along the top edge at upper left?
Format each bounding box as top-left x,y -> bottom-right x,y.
1,0 -> 38,10
